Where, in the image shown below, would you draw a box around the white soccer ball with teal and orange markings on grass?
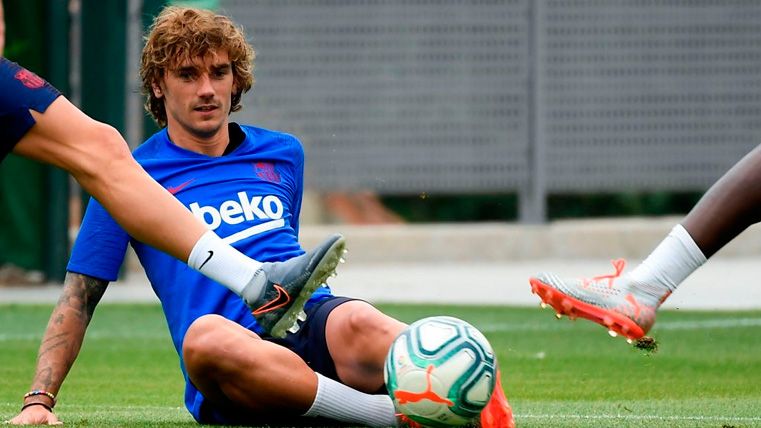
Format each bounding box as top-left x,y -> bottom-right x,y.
383,316 -> 497,427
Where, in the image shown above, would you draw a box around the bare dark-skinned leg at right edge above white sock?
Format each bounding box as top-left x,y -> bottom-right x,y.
682,146 -> 761,258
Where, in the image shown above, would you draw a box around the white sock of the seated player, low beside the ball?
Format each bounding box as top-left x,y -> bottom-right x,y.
304,373 -> 396,427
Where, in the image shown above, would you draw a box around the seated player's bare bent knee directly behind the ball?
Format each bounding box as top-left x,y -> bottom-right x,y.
325,300 -> 406,393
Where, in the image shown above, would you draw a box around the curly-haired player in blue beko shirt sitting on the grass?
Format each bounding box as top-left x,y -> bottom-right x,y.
11,7 -> 512,428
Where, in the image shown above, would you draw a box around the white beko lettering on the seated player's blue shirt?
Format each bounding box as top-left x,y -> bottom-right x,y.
189,192 -> 285,243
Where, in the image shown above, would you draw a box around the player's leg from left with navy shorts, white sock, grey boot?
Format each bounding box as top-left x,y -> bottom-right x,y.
0,5 -> 345,335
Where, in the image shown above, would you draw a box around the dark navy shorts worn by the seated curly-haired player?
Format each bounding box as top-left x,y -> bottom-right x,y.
188,297 -> 356,426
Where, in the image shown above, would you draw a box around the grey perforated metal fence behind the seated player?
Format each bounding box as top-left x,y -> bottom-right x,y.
220,0 -> 761,221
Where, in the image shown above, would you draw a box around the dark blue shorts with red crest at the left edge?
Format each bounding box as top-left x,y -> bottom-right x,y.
0,57 -> 61,161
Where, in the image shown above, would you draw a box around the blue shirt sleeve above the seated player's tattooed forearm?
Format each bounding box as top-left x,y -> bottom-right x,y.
66,198 -> 130,281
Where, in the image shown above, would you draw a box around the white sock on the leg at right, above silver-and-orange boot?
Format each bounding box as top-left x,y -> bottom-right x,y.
628,224 -> 706,298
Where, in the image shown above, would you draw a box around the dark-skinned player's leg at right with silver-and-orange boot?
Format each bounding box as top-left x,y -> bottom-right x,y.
529,146 -> 761,340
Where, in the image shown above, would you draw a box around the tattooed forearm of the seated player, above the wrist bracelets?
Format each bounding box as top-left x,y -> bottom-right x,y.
26,272 -> 108,393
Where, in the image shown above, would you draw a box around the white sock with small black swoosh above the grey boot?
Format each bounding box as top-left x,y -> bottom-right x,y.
188,230 -> 262,296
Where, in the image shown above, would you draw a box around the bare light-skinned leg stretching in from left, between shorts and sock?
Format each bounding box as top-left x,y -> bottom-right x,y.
13,97 -> 206,261
